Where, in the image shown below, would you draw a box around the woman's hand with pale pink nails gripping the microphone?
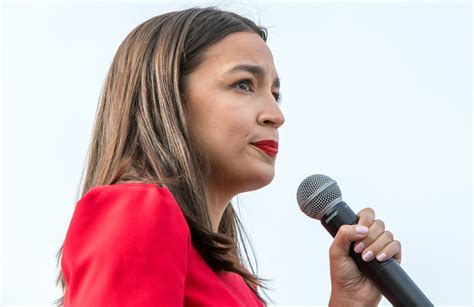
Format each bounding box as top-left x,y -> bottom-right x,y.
329,208 -> 402,306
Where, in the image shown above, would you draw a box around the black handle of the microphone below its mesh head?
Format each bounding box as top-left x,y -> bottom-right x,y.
321,201 -> 433,306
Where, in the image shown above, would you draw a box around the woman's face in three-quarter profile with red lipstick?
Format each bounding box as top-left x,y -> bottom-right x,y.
185,32 -> 285,194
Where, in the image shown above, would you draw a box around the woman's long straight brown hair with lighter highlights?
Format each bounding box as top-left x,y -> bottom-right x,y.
55,7 -> 271,306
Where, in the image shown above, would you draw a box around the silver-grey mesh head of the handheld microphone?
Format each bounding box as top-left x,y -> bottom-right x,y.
296,174 -> 342,220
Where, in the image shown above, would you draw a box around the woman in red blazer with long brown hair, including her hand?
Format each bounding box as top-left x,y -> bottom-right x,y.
58,8 -> 401,306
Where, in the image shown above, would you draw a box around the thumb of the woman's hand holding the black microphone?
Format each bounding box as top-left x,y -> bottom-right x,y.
329,225 -> 369,259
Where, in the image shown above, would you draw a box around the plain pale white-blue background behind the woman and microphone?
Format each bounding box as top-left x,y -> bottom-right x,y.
0,1 -> 473,306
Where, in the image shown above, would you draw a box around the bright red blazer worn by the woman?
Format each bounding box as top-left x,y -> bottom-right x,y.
61,183 -> 263,307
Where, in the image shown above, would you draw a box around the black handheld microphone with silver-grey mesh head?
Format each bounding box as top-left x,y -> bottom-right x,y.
296,175 -> 433,306
